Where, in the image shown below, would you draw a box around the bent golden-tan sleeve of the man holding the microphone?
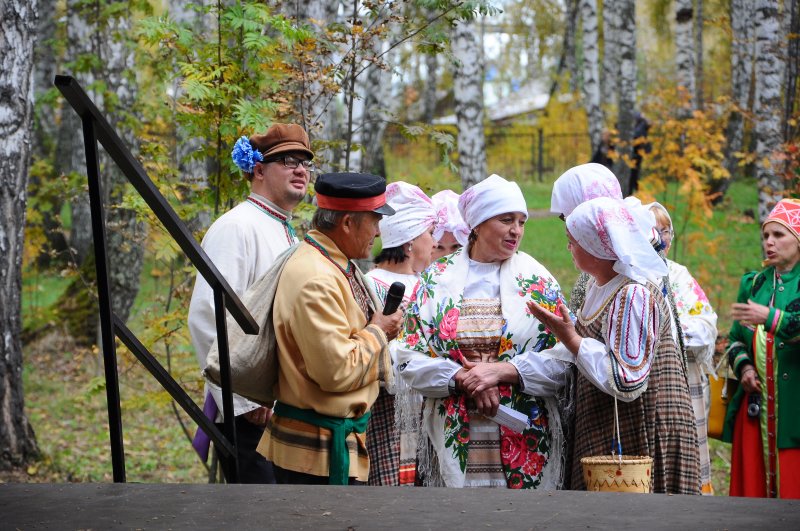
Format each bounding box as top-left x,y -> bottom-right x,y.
291,278 -> 392,392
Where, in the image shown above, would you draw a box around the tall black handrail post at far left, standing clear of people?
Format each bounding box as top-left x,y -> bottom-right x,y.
81,114 -> 125,483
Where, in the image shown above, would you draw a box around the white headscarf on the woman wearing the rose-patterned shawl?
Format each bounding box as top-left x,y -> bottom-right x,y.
458,174 -> 528,229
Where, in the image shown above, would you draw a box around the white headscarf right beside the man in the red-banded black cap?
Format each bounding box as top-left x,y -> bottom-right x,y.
380,181 -> 436,249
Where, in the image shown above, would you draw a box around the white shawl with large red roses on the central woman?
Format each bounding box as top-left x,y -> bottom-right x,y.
398,249 -> 564,488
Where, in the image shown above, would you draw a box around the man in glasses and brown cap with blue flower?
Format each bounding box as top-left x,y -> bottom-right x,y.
189,124 -> 314,483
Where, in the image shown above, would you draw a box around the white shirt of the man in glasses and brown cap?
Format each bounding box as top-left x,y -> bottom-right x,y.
188,194 -> 295,416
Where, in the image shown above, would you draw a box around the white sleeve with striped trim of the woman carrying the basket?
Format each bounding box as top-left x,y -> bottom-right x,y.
578,284 -> 660,402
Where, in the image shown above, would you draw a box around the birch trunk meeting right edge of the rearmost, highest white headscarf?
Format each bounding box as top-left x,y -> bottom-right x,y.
614,0 -> 636,194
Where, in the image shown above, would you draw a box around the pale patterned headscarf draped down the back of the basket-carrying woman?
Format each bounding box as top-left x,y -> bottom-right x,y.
567,197 -> 667,284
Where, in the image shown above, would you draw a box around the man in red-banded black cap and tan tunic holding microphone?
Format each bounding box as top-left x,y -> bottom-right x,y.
258,173 -> 403,485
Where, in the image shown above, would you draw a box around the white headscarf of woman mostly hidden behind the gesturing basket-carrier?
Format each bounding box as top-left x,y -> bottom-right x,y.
550,162 -> 622,216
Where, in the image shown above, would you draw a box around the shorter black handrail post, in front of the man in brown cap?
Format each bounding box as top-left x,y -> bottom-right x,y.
214,286 -> 239,483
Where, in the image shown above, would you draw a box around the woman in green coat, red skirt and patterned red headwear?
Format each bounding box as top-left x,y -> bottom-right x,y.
723,199 -> 800,499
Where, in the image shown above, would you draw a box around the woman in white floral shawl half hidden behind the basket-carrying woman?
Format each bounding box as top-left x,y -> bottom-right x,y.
645,203 -> 717,495
